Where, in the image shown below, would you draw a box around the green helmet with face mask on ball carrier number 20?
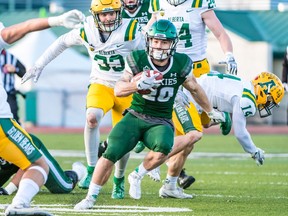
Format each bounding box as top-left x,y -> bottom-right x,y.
145,19 -> 178,61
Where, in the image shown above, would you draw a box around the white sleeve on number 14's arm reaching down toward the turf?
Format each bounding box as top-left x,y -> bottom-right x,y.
232,98 -> 257,154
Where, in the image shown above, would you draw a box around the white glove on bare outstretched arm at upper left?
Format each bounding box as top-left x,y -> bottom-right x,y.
48,10 -> 85,28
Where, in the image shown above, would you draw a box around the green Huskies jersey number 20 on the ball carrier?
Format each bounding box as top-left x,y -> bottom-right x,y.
127,50 -> 193,119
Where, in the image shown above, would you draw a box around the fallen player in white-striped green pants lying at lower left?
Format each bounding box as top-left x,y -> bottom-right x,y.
0,134 -> 86,195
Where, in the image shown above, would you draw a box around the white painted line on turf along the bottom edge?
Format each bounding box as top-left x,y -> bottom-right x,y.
0,204 -> 193,215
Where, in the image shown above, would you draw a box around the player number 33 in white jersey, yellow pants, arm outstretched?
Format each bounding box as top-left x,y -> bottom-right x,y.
22,0 -> 145,198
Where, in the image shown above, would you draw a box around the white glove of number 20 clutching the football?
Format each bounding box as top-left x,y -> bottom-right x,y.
136,72 -> 162,91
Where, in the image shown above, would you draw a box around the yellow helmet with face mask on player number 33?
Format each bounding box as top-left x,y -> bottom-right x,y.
90,0 -> 122,32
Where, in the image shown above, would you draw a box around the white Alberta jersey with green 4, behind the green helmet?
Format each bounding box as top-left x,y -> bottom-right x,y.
149,0 -> 216,62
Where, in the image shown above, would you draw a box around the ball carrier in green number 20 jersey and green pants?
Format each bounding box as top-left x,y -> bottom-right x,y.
74,20 -> 223,210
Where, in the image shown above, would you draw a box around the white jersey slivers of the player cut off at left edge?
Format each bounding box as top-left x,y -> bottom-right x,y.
0,22 -> 13,118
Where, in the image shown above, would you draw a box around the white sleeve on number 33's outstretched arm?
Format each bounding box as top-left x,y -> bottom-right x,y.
35,29 -> 82,68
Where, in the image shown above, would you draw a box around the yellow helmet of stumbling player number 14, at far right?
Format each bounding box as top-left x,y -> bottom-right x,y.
252,72 -> 284,118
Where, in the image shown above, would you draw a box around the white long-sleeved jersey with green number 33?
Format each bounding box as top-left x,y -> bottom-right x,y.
36,16 -> 145,88
